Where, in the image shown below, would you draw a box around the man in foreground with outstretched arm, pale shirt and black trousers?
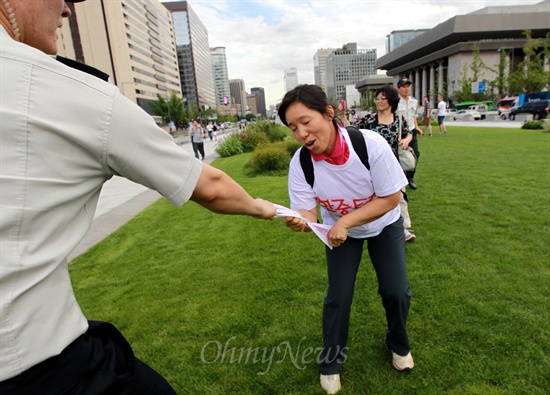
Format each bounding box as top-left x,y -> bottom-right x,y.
0,0 -> 276,395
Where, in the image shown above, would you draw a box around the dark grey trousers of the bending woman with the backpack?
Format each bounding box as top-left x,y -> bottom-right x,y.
319,218 -> 412,374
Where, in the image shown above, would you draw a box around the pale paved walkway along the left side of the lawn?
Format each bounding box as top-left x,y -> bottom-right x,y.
68,129 -> 236,261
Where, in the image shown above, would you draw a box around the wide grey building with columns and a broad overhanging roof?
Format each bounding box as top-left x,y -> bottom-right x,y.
376,0 -> 550,100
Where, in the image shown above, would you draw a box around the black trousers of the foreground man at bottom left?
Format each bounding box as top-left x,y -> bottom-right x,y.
0,321 -> 176,395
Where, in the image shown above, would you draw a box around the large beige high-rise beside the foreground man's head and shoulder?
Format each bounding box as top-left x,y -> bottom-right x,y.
58,0 -> 182,113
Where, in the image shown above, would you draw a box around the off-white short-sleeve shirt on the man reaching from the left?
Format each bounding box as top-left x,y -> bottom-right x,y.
0,26 -> 202,381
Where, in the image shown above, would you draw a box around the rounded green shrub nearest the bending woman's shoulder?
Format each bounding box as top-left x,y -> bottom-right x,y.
245,144 -> 290,176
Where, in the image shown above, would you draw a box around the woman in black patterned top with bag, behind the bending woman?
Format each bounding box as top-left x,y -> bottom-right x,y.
366,85 -> 416,241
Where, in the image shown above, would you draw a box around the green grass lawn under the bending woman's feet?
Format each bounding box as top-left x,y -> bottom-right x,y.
70,127 -> 550,395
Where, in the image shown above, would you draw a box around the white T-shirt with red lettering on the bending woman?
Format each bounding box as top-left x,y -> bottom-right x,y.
288,128 -> 408,238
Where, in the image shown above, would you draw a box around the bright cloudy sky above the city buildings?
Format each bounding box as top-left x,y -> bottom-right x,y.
164,0 -> 541,110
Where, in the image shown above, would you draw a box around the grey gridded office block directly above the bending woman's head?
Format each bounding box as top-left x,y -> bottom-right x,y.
327,43 -> 377,100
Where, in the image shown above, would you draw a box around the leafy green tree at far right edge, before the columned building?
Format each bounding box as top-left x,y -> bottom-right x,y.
509,30 -> 550,94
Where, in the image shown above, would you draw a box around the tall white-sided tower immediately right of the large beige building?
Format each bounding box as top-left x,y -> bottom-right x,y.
162,1 -> 216,109
